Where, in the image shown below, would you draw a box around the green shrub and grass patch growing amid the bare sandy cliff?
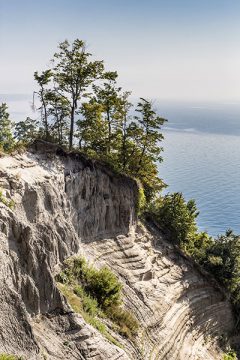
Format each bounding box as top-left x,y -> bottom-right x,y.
56,257 -> 139,346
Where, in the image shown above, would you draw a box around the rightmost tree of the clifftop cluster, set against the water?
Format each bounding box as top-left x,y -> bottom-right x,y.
122,98 -> 167,200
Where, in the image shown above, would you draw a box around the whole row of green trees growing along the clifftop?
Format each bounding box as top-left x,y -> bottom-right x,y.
0,39 -> 166,198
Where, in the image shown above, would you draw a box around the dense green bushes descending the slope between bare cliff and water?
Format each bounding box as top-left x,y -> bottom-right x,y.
149,193 -> 240,327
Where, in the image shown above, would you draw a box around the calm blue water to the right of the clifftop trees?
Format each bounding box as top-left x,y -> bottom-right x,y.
159,104 -> 240,236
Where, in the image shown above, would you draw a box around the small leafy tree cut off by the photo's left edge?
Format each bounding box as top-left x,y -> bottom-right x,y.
0,103 -> 14,151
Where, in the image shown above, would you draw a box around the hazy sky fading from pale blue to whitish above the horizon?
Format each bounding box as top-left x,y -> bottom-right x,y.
0,0 -> 240,102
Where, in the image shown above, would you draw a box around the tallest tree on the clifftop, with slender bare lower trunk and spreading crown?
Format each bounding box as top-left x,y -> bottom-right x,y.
53,39 -> 104,149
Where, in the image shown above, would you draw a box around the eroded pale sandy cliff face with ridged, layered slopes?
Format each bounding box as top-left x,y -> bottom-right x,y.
0,143 -> 233,360
